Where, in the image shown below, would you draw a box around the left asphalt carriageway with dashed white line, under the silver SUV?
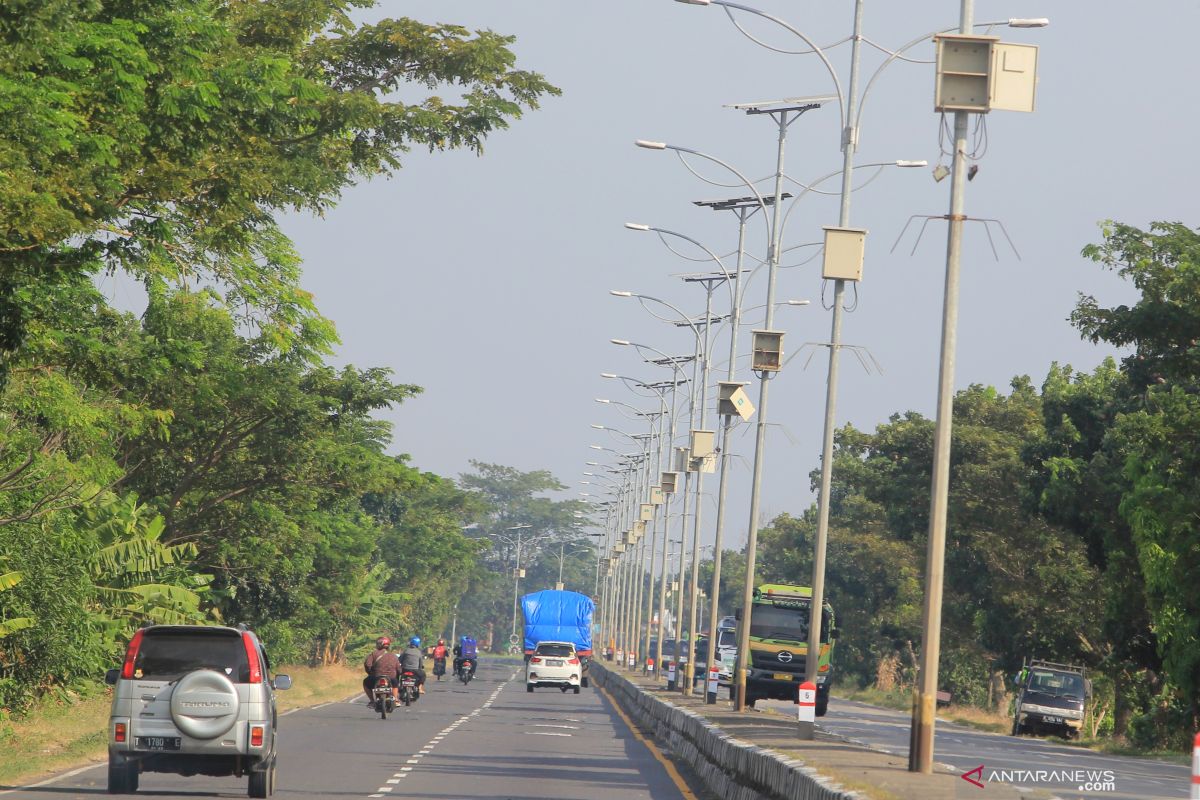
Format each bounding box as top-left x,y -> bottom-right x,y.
0,661 -> 694,800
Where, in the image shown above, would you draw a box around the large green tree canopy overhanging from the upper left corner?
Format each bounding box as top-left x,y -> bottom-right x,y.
0,0 -> 558,355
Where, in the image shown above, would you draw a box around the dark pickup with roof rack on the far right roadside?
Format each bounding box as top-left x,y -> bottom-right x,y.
1013,658 -> 1092,739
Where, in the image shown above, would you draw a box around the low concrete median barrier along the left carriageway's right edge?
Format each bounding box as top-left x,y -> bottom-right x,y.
592,662 -> 860,800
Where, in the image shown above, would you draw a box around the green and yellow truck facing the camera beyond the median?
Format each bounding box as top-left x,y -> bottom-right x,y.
730,583 -> 838,716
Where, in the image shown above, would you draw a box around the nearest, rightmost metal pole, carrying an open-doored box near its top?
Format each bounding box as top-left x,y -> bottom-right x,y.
908,0 -> 974,774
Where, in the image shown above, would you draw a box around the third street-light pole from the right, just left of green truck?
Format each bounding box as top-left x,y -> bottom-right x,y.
734,110 -> 787,711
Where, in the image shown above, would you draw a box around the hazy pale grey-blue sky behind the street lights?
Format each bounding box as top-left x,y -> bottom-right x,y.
274,0 -> 1200,547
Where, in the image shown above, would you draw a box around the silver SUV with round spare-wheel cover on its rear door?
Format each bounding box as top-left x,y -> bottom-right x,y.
104,625 -> 292,798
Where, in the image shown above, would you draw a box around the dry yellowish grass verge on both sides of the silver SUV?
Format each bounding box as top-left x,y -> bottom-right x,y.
0,664 -> 362,788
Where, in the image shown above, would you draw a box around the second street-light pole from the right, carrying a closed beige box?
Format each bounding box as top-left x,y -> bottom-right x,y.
804,0 -> 863,714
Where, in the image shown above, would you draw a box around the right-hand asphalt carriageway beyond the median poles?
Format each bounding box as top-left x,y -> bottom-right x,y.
761,698 -> 1192,800
